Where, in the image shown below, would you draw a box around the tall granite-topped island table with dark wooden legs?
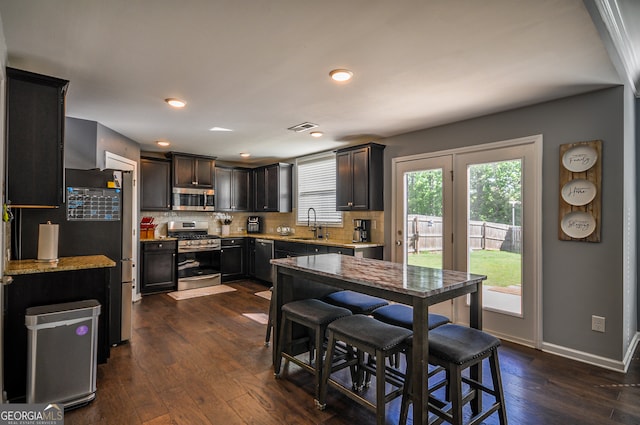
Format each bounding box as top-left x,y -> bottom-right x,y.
271,254 -> 486,424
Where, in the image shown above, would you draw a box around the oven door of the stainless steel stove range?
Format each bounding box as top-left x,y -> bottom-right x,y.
177,248 -> 221,291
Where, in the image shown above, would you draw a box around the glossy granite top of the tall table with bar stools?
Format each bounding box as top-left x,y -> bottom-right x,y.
271,254 -> 487,298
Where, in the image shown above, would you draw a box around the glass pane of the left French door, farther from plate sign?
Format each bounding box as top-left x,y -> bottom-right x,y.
404,168 -> 443,269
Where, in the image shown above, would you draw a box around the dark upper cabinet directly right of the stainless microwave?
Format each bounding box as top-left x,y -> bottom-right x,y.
214,167 -> 251,211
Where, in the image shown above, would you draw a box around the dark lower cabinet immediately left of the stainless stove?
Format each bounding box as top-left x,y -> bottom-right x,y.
140,240 -> 178,295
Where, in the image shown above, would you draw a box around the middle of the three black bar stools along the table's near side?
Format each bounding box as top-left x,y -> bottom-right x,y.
317,314 -> 412,424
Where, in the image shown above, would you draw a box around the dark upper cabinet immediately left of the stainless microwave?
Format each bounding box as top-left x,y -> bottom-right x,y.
140,157 -> 171,211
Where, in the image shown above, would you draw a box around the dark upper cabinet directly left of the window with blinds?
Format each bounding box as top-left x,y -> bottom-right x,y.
253,163 -> 293,212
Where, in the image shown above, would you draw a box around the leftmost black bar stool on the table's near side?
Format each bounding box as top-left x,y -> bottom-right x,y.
274,298 -> 351,399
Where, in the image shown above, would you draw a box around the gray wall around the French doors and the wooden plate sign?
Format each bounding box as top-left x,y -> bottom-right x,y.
384,87 -> 635,360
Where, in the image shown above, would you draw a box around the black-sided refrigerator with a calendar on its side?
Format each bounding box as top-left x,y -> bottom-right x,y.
12,168 -> 135,345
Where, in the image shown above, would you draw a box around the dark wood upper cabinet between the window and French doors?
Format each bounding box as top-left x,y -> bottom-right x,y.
336,143 -> 384,211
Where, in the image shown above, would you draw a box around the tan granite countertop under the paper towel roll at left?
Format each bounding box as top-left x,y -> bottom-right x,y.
4,255 -> 116,276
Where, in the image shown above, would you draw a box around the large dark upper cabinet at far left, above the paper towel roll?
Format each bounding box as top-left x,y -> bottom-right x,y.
6,68 -> 69,207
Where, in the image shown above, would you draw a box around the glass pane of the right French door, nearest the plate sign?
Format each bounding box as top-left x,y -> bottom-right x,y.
468,159 -> 523,315
